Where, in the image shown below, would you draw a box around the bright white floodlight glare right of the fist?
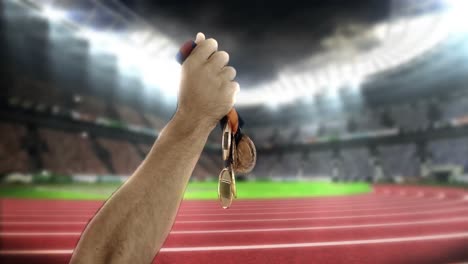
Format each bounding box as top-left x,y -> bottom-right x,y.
238,10 -> 452,106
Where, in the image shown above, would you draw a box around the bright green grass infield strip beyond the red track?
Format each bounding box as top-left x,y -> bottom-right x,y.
0,182 -> 371,200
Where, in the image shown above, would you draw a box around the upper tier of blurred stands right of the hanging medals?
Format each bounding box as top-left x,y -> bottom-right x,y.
249,91 -> 468,146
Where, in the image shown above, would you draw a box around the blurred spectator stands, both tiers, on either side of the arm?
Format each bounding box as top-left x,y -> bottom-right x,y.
0,78 -> 468,180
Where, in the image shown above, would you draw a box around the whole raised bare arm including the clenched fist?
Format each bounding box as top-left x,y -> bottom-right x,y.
70,33 -> 239,264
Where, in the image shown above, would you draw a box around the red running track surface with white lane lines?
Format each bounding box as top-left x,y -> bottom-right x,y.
0,186 -> 468,264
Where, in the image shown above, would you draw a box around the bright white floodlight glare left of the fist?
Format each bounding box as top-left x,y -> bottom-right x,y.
33,1 -> 180,101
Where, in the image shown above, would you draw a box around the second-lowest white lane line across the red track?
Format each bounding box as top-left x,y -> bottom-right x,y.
0,217 -> 468,237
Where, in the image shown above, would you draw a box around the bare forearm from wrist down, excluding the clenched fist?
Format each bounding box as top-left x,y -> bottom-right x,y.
72,115 -> 213,263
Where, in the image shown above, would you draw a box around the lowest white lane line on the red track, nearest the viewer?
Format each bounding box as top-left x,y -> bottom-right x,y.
0,232 -> 468,256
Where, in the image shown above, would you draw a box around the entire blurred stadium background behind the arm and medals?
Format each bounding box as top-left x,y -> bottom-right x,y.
0,0 -> 468,263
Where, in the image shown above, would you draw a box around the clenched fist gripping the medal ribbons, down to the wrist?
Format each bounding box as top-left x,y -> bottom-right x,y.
177,33 -> 239,128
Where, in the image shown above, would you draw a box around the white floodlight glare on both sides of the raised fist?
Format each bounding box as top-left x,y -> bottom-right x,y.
35,0 -> 458,108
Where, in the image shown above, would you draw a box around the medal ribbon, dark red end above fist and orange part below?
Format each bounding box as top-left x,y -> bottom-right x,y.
176,40 -> 244,144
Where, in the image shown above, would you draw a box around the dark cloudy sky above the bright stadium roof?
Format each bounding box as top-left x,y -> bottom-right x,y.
120,0 -> 390,83
